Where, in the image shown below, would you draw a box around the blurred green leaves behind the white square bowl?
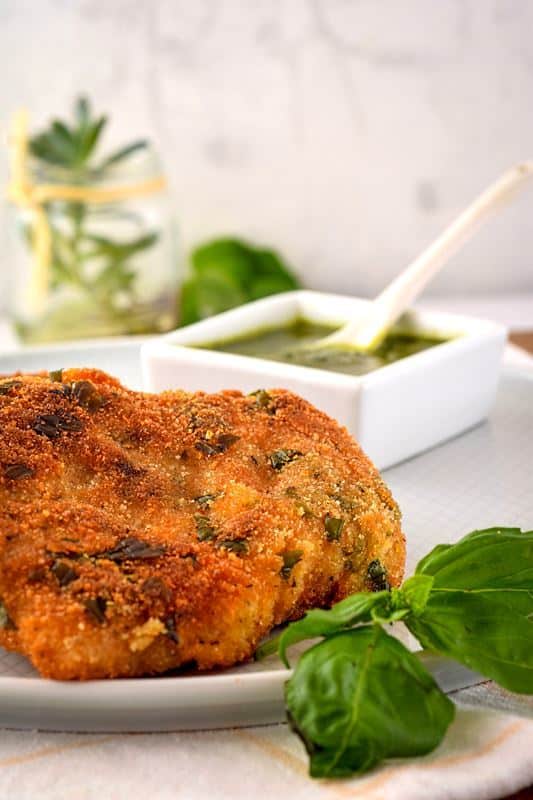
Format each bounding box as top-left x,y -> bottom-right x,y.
181,239 -> 300,325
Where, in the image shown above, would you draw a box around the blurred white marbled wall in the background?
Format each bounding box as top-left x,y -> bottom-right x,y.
0,0 -> 533,294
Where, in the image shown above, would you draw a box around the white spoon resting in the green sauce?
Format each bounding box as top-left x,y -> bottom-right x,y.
310,161 -> 533,353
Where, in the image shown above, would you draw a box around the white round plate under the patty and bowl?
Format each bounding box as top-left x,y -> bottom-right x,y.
0,341 -> 533,731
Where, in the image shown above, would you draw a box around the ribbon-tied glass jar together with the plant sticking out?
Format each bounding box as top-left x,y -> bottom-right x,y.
9,97 -> 177,342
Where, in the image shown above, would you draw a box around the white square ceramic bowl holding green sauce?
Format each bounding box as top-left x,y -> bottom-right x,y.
141,291 -> 506,469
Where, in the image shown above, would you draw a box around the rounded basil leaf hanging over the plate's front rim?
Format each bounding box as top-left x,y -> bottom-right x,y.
285,626 -> 454,777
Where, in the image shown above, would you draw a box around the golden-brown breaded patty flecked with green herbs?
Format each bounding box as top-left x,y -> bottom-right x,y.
0,369 -> 405,679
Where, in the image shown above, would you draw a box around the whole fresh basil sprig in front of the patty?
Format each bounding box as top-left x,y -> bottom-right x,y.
264,528 -> 533,777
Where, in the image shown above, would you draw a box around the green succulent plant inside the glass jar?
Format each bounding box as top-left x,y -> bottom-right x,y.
26,97 -> 159,334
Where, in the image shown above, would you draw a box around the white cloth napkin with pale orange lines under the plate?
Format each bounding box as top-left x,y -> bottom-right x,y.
0,709 -> 533,800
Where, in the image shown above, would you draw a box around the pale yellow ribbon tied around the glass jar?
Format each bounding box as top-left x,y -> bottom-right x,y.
7,109 -> 166,310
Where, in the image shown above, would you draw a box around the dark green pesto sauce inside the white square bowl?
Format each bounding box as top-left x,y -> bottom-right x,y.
197,318 -> 446,375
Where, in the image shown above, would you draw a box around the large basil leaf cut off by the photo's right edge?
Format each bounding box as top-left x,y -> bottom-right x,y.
404,528 -> 533,694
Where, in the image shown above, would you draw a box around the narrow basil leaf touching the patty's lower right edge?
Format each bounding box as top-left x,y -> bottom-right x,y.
256,591 -> 409,667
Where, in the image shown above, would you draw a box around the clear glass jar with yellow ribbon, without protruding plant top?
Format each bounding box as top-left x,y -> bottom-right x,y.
8,149 -> 180,343
